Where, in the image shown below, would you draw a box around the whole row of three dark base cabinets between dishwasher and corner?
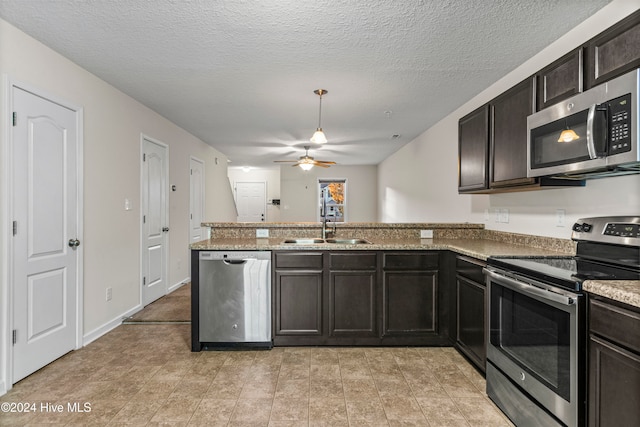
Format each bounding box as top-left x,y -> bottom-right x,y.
273,251 -> 451,346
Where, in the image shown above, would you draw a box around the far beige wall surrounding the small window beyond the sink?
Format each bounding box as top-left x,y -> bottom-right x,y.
280,165 -> 378,222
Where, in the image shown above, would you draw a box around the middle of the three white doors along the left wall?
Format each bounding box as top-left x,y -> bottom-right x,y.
142,137 -> 169,305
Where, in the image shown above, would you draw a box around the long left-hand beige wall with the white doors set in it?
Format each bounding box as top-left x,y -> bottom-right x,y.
0,15 -> 235,392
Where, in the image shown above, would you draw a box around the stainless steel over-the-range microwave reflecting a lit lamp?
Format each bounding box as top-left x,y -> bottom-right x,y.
527,69 -> 640,179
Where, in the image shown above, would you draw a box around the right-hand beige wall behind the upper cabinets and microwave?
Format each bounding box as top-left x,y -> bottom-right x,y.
378,0 -> 640,238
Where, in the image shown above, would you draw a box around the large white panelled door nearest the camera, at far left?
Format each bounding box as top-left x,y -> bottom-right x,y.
12,86 -> 81,383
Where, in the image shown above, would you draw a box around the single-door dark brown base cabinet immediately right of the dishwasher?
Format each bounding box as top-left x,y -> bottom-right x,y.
273,251 -> 325,345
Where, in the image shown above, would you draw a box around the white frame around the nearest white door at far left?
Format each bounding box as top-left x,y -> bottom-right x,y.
0,74 -> 85,395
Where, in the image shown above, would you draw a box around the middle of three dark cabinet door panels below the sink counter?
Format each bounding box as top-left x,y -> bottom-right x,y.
329,270 -> 378,338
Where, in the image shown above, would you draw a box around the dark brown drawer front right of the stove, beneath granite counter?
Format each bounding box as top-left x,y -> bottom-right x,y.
589,299 -> 640,353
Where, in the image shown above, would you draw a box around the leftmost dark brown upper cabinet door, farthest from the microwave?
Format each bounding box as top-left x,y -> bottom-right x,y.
458,105 -> 489,193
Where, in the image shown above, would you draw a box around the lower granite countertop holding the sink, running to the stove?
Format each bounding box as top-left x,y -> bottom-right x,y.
190,238 -> 573,260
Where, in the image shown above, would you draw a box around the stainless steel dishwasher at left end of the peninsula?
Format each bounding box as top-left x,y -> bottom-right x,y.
199,251 -> 272,348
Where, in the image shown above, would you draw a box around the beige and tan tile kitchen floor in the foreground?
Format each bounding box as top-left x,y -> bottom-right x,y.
0,324 -> 512,427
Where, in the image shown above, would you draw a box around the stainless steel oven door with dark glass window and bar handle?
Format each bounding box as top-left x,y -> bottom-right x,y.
485,268 -> 582,426
